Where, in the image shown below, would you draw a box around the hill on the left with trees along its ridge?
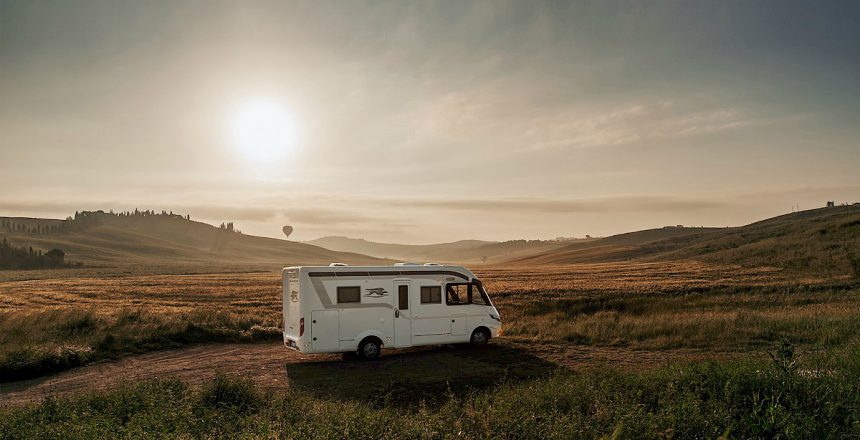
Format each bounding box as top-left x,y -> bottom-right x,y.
0,211 -> 384,267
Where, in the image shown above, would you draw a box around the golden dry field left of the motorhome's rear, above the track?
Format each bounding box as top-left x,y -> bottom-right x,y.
0,274 -> 281,381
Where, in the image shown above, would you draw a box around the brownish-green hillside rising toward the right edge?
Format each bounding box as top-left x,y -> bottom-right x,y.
510,205 -> 860,276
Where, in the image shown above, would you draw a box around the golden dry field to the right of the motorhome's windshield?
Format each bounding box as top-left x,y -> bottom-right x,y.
479,262 -> 860,351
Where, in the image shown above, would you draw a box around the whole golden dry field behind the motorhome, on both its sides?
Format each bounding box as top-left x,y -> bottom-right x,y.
0,262 -> 860,380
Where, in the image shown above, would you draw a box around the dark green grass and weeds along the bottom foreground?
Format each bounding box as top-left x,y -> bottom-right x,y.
0,349 -> 860,439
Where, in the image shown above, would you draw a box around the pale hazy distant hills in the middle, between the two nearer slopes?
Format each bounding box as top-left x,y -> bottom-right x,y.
305,236 -> 585,263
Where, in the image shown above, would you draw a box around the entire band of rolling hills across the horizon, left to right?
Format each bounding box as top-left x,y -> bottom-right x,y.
8,205 -> 860,276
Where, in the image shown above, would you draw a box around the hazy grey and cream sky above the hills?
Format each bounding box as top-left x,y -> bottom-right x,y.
0,0 -> 860,243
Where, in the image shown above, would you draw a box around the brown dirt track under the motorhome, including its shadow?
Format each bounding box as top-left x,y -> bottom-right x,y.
0,341 -> 731,405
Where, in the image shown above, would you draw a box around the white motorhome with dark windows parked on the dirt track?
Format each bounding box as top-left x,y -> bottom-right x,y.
283,263 -> 502,359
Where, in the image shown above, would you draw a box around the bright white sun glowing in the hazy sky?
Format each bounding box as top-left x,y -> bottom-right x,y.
231,99 -> 298,164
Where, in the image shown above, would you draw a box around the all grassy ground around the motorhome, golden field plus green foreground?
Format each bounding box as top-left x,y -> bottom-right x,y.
0,262 -> 860,438
